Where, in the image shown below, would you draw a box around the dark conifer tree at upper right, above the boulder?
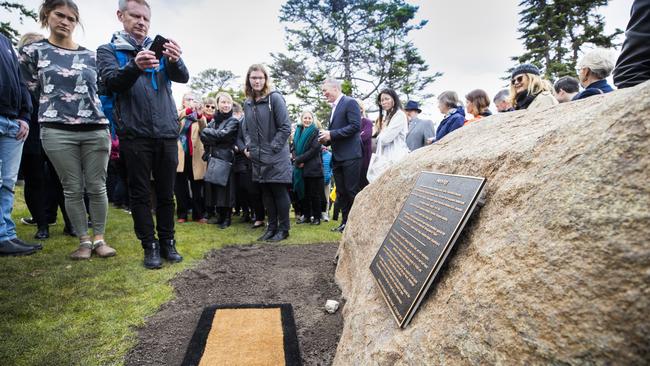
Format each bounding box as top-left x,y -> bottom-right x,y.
510,0 -> 623,80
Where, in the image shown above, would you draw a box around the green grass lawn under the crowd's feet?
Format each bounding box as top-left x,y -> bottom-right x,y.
0,187 -> 340,365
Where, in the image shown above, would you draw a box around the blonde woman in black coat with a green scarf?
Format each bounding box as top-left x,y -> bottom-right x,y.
293,112 -> 325,225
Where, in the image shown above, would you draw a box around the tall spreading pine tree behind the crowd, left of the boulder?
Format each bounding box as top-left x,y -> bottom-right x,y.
271,0 -> 441,124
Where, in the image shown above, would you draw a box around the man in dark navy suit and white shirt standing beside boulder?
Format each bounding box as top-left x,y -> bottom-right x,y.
318,78 -> 362,232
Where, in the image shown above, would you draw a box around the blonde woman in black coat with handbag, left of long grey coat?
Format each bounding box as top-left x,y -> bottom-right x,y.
201,93 -> 239,229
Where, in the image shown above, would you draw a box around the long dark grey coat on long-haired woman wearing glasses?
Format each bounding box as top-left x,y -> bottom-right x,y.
244,92 -> 293,184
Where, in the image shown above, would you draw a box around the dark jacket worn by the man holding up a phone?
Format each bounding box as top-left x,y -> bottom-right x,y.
97,31 -> 190,139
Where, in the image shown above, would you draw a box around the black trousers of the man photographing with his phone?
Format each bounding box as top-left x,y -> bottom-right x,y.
120,138 -> 178,244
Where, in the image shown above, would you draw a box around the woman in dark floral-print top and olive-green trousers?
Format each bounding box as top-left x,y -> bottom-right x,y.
19,0 -> 115,259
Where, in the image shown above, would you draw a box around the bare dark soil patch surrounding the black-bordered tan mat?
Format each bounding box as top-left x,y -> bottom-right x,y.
126,244 -> 343,365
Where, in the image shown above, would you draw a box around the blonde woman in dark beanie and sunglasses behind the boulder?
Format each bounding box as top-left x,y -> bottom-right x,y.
510,64 -> 558,110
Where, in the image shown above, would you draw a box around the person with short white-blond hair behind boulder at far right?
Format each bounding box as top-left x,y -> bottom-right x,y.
572,48 -> 614,100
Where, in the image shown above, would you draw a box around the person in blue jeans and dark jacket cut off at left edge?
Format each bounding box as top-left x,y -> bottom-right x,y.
0,34 -> 42,256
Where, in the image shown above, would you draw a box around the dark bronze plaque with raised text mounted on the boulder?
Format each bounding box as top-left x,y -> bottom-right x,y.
370,172 -> 486,328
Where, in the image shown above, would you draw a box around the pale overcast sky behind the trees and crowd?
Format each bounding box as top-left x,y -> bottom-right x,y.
0,0 -> 632,121
